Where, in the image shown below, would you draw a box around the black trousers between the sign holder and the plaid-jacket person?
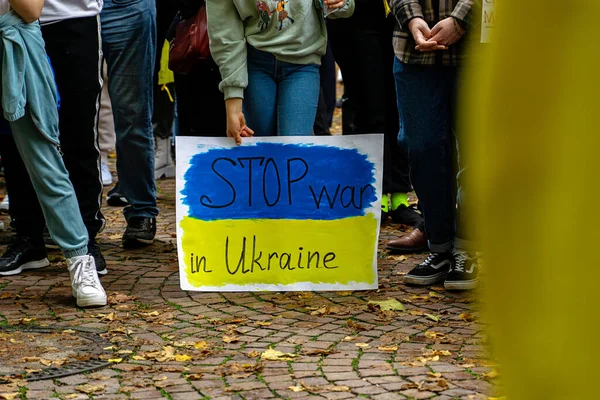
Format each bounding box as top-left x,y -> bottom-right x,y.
328,10 -> 412,193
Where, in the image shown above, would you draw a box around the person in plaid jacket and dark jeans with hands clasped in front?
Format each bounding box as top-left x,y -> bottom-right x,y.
392,0 -> 478,290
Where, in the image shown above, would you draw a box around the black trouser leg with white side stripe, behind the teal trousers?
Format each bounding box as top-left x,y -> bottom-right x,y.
42,17 -> 105,239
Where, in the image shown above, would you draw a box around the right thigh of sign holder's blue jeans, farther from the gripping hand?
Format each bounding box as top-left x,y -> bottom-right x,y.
277,62 -> 321,136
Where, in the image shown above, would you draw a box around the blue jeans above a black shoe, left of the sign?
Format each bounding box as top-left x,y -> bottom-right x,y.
100,0 -> 158,220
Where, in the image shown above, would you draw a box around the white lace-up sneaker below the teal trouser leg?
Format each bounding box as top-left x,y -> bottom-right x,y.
67,255 -> 106,307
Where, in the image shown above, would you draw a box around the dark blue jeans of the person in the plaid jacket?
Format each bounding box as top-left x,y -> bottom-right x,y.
394,59 -> 456,252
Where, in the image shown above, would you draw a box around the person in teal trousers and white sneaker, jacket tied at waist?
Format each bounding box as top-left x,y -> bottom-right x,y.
0,0 -> 106,307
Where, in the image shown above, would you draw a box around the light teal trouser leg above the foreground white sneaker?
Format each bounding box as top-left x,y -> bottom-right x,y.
10,113 -> 88,258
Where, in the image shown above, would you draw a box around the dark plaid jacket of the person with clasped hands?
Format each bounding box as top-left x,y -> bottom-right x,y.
391,0 -> 481,65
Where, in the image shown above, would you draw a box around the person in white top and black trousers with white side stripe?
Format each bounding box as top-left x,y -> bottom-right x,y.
0,0 -> 107,275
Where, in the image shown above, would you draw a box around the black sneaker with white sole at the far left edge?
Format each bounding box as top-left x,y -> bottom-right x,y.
0,236 -> 50,276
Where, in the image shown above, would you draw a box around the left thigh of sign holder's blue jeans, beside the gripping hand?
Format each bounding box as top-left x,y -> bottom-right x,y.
244,46 -> 278,136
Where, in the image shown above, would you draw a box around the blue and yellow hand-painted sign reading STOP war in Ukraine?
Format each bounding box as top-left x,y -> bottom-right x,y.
177,135 -> 383,291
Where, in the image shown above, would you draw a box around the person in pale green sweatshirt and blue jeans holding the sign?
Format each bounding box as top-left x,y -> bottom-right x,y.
206,0 -> 354,143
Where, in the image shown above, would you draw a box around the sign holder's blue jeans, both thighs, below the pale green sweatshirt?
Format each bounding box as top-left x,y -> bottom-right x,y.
244,46 -> 320,136
